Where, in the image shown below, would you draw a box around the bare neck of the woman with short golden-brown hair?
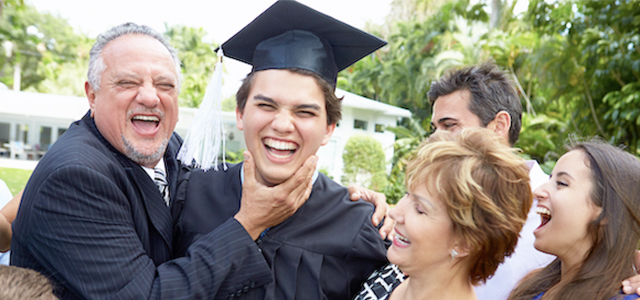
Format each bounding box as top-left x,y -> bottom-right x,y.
391,268 -> 477,300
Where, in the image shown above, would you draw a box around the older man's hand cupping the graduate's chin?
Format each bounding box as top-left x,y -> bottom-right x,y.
235,151 -> 318,240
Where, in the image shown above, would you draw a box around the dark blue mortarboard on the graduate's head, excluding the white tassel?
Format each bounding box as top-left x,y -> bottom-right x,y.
222,0 -> 386,87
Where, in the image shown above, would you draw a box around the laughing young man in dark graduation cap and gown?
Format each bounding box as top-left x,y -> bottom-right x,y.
174,1 -> 386,299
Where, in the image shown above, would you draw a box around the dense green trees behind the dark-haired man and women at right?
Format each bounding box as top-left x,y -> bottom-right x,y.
338,0 -> 640,192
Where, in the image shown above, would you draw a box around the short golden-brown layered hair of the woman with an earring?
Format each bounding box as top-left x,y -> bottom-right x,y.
406,128 -> 533,284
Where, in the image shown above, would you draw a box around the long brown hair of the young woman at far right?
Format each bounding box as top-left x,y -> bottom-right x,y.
508,140 -> 640,300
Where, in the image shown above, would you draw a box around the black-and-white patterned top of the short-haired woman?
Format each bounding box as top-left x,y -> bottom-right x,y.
354,264 -> 407,300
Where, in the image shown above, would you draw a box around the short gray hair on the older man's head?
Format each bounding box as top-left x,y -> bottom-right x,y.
87,23 -> 181,92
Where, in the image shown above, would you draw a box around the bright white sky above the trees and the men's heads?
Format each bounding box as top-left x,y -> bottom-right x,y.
25,0 -> 392,97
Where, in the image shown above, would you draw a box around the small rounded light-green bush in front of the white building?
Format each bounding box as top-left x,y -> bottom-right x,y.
342,135 -> 387,191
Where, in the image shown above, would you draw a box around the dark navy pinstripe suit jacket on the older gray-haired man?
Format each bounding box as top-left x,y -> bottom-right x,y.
11,113 -> 272,299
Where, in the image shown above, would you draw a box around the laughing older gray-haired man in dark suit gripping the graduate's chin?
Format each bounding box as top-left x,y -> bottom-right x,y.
11,23 -> 317,299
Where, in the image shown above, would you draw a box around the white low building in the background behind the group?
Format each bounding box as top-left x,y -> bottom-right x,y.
0,89 -> 411,180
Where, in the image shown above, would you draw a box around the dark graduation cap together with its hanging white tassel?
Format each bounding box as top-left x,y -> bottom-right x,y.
178,0 -> 386,169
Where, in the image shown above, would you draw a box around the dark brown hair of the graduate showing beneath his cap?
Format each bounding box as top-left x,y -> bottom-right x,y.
236,69 -> 342,125
